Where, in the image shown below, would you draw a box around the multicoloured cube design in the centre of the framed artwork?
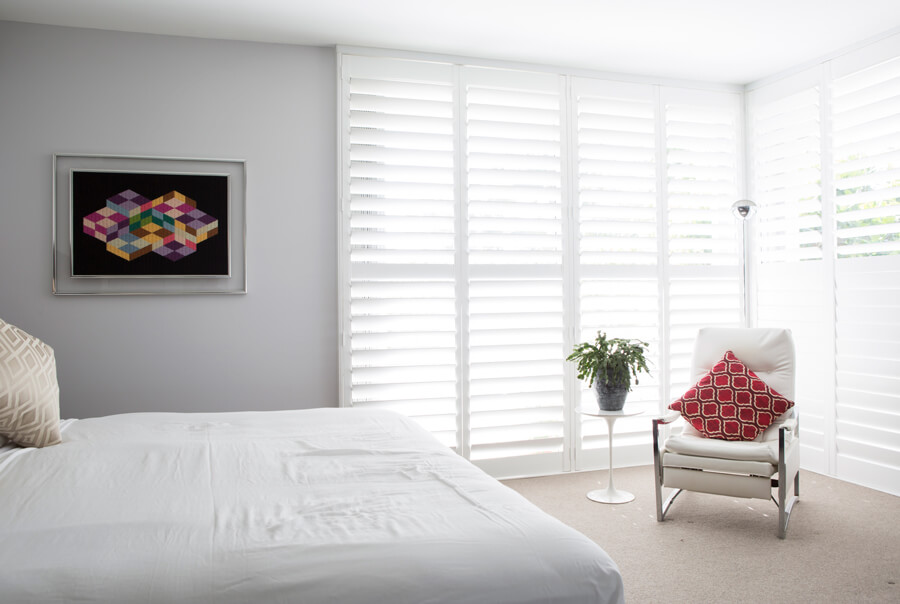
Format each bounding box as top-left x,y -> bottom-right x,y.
82,189 -> 219,262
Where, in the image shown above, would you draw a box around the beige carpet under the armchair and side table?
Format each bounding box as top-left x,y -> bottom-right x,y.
504,466 -> 900,604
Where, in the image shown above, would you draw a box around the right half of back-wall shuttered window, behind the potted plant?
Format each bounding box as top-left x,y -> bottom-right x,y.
574,78 -> 741,467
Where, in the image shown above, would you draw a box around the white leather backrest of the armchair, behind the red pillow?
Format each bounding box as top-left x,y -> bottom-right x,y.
691,327 -> 796,401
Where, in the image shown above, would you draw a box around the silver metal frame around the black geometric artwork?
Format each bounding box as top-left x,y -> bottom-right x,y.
51,153 -> 247,295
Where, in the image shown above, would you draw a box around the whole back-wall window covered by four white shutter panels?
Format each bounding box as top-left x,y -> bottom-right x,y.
340,53 -> 742,476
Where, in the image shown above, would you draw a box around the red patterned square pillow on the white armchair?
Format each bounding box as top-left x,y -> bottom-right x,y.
669,350 -> 794,440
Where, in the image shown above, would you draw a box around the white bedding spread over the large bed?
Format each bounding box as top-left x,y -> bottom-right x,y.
0,409 -> 623,604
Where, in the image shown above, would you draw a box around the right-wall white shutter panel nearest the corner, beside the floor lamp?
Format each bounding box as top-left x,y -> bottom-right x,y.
748,68 -> 833,472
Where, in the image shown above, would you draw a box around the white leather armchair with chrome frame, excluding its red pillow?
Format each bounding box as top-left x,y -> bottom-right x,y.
653,328 -> 800,539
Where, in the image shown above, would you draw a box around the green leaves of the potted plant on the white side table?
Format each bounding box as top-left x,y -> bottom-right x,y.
566,331 -> 650,390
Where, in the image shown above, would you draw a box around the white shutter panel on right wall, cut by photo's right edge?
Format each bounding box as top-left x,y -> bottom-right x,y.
833,54 -> 900,493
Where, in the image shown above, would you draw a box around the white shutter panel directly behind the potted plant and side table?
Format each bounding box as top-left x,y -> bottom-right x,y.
573,78 -> 660,468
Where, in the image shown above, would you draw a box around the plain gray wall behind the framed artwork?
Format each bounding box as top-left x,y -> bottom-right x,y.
0,21 -> 338,417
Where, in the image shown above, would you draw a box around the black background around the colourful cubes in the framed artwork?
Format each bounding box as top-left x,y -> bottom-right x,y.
72,170 -> 229,277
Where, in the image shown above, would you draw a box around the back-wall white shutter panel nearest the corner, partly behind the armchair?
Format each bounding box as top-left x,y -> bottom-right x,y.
662,88 -> 741,399
